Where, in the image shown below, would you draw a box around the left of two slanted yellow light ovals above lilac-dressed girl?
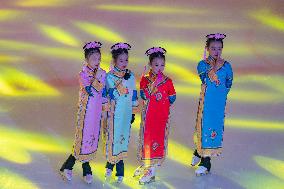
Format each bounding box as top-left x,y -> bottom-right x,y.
39,24 -> 80,46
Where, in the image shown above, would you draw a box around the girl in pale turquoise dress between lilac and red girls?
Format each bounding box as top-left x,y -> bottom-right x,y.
104,43 -> 138,184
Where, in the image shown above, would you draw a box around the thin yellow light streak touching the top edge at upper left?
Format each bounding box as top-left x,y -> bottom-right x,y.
15,0 -> 70,7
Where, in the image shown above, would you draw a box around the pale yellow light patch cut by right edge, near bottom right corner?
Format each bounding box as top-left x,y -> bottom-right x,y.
253,156 -> 284,181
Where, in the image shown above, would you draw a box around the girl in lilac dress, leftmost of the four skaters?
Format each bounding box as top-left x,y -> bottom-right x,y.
60,41 -> 107,184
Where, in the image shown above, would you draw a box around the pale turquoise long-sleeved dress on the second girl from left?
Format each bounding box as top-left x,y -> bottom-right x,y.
104,67 -> 138,164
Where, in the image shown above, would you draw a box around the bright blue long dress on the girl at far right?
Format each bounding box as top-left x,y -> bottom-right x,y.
194,56 -> 233,157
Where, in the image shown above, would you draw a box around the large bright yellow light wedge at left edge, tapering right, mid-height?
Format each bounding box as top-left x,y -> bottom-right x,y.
0,67 -> 60,97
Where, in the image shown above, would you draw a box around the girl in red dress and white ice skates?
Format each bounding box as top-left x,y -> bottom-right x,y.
134,47 -> 176,184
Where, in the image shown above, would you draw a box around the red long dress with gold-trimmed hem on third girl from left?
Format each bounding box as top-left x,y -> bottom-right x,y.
138,72 -> 176,166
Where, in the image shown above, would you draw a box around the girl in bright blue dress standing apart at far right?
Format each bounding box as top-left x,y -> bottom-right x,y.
191,33 -> 233,176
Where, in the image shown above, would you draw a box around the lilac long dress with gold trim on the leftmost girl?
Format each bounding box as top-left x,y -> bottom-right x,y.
73,65 -> 107,162
